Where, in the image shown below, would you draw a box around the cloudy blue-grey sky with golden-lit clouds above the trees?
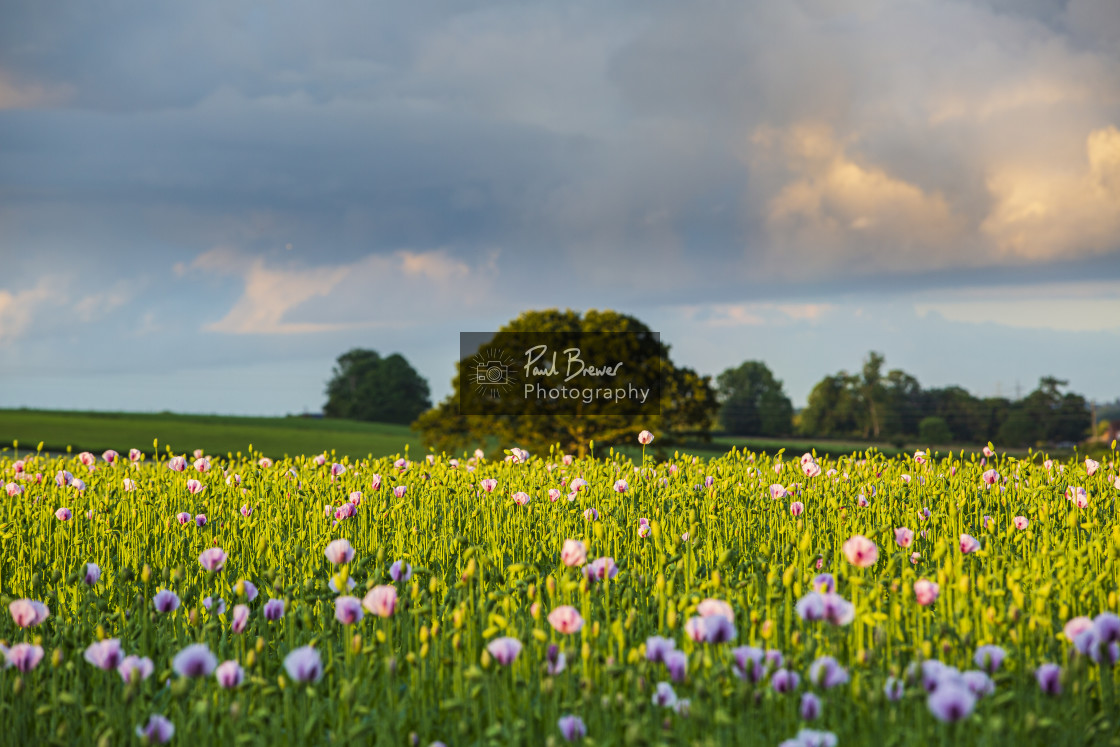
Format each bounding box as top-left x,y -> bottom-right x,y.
0,0 -> 1120,414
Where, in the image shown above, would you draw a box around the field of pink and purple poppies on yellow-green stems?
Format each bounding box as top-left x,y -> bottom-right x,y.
0,439 -> 1120,747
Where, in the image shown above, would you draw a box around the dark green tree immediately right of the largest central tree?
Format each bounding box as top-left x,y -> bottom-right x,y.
716,361 -> 793,436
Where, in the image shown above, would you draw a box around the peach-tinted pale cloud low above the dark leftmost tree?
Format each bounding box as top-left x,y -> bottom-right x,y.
191,248 -> 496,335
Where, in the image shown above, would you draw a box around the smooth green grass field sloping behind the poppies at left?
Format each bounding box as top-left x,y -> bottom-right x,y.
0,410 -> 420,458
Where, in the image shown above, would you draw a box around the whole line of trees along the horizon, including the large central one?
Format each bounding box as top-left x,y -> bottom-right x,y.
324,309 -> 1091,451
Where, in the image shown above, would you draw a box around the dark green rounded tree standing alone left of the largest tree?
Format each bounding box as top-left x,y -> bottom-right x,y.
323,348 -> 431,423
